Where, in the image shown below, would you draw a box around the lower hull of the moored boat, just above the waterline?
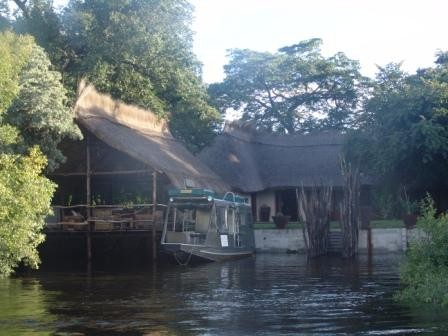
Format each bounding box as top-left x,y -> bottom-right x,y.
164,244 -> 254,262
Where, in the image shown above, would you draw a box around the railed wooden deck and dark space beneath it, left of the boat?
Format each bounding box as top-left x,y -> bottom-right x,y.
41,204 -> 166,264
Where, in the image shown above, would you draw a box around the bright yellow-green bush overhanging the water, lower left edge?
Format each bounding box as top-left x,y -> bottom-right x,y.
0,147 -> 55,275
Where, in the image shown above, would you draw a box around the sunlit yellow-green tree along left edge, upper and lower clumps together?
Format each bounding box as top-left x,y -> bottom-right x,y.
0,32 -> 54,276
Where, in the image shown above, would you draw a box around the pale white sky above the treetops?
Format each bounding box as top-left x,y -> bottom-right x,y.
190,0 -> 448,83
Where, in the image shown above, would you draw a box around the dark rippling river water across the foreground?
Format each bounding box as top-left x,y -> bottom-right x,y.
0,255 -> 448,335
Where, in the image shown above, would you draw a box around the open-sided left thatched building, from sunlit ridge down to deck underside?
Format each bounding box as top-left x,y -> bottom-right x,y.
44,84 -> 234,265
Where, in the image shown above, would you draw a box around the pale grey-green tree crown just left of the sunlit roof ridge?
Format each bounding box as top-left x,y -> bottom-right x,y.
5,45 -> 82,171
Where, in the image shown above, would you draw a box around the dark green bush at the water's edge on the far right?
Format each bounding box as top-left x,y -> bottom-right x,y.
397,196 -> 448,306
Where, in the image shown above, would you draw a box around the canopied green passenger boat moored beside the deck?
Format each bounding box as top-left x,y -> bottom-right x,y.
161,189 -> 255,263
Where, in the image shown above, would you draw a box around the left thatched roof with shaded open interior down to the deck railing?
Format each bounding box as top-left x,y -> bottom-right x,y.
51,85 -> 230,205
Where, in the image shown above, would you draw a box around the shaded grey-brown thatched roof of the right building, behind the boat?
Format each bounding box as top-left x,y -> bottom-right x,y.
199,123 -> 354,192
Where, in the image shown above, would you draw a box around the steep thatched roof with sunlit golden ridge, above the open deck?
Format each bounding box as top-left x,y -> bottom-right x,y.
75,84 -> 229,192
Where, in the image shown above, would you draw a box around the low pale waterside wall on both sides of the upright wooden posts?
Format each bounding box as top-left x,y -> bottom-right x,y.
254,228 -> 418,253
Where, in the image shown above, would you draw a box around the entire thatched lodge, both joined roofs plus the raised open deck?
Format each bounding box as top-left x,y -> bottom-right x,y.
45,85 -> 374,262
